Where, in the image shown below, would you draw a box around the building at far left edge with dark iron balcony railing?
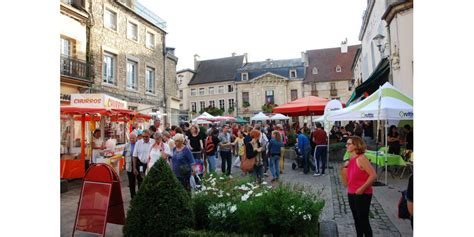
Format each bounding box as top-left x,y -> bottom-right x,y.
59,0 -> 92,105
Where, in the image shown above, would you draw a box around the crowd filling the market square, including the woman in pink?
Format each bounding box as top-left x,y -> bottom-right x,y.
119,120 -> 413,236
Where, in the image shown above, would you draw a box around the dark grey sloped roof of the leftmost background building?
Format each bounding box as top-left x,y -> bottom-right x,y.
188,55 -> 245,85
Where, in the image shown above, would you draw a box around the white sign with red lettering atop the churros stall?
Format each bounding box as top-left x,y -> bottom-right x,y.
71,94 -> 127,109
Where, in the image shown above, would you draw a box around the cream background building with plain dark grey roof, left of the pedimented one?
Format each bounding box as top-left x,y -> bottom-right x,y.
188,54 -> 247,118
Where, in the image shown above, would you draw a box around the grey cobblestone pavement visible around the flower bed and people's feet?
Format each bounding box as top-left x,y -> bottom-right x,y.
61,156 -> 413,237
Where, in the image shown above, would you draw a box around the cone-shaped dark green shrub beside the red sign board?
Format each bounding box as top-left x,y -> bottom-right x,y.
123,159 -> 194,236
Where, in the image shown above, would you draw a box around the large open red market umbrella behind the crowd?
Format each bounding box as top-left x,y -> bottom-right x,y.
273,96 -> 329,116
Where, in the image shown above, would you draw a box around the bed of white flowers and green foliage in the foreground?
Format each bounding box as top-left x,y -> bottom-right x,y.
192,174 -> 324,236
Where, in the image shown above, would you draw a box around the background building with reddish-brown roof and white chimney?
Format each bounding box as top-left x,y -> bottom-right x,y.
303,41 -> 360,102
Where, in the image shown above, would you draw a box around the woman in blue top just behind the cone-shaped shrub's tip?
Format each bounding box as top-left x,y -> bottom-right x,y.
171,134 -> 194,191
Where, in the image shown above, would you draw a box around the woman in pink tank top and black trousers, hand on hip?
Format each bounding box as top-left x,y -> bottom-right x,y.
342,136 -> 377,237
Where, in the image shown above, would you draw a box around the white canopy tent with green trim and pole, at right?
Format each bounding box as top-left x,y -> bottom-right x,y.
326,82 -> 413,184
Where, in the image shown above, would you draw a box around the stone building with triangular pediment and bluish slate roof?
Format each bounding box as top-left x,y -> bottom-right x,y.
235,58 -> 304,120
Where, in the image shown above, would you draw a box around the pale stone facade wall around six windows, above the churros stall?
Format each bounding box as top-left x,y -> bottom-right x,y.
90,0 -> 168,106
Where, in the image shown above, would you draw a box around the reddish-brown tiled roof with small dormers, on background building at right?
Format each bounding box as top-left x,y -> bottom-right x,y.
303,44 -> 361,83
